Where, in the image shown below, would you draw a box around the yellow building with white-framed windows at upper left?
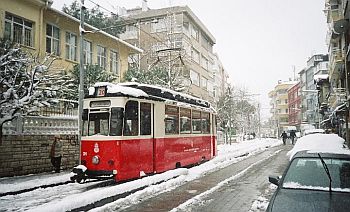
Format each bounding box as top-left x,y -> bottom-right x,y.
0,0 -> 142,76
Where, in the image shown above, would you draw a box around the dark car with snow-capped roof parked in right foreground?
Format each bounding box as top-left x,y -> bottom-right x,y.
266,151 -> 350,212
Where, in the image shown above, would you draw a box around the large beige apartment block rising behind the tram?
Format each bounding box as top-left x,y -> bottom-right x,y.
120,1 -> 226,102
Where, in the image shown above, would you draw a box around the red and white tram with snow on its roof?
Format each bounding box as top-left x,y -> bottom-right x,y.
72,83 -> 217,182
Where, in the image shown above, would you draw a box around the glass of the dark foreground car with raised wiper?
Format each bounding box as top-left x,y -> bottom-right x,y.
282,158 -> 350,192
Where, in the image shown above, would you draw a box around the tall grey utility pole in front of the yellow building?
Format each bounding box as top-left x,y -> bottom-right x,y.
78,0 -> 86,164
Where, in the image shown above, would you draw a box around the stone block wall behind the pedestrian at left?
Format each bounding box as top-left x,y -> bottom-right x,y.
0,135 -> 79,177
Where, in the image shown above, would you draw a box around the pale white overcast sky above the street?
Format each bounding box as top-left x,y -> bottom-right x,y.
53,0 -> 327,118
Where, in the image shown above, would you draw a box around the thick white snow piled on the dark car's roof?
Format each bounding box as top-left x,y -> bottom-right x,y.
287,134 -> 350,159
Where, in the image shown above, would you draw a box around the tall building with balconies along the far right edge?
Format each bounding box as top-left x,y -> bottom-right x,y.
320,0 -> 350,140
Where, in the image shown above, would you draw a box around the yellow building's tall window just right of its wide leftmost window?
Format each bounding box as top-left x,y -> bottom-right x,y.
46,24 -> 60,56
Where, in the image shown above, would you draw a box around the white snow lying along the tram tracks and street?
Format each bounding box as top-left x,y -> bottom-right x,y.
0,139 -> 281,211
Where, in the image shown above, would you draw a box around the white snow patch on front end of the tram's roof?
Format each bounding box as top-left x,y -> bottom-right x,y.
89,82 -> 148,97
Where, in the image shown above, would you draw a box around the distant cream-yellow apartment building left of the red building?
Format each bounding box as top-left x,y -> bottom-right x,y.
269,81 -> 298,136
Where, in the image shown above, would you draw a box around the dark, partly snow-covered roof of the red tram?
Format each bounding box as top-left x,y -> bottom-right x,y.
86,82 -> 211,108
